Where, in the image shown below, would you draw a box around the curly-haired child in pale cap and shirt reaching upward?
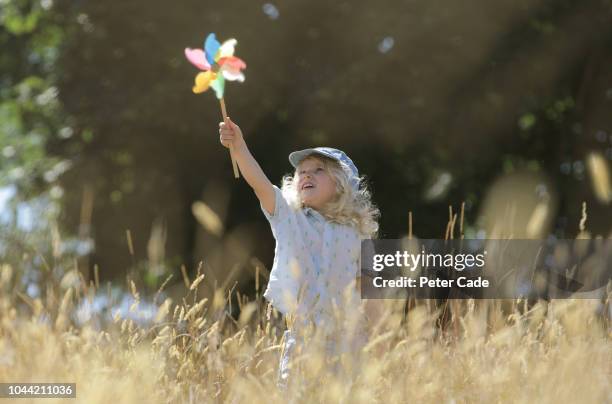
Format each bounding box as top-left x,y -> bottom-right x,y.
219,118 -> 380,388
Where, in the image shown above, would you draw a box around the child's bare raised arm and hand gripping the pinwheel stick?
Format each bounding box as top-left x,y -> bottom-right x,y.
219,117 -> 274,215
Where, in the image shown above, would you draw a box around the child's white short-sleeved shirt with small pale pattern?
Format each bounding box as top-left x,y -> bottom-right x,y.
260,185 -> 361,325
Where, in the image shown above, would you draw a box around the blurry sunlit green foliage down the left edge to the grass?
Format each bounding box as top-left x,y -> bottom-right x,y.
0,0 -> 84,296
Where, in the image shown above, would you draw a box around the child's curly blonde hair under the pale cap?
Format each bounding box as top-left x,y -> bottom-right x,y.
281,155 -> 380,238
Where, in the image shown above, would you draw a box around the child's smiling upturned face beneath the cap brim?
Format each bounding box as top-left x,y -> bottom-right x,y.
297,157 -> 336,210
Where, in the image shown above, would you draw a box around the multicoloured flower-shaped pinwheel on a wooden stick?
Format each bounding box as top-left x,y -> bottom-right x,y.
185,33 -> 246,178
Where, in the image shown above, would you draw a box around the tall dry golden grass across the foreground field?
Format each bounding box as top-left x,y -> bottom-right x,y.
0,258 -> 612,404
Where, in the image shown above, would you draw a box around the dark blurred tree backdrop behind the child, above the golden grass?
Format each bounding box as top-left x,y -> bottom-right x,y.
0,0 -> 612,300
